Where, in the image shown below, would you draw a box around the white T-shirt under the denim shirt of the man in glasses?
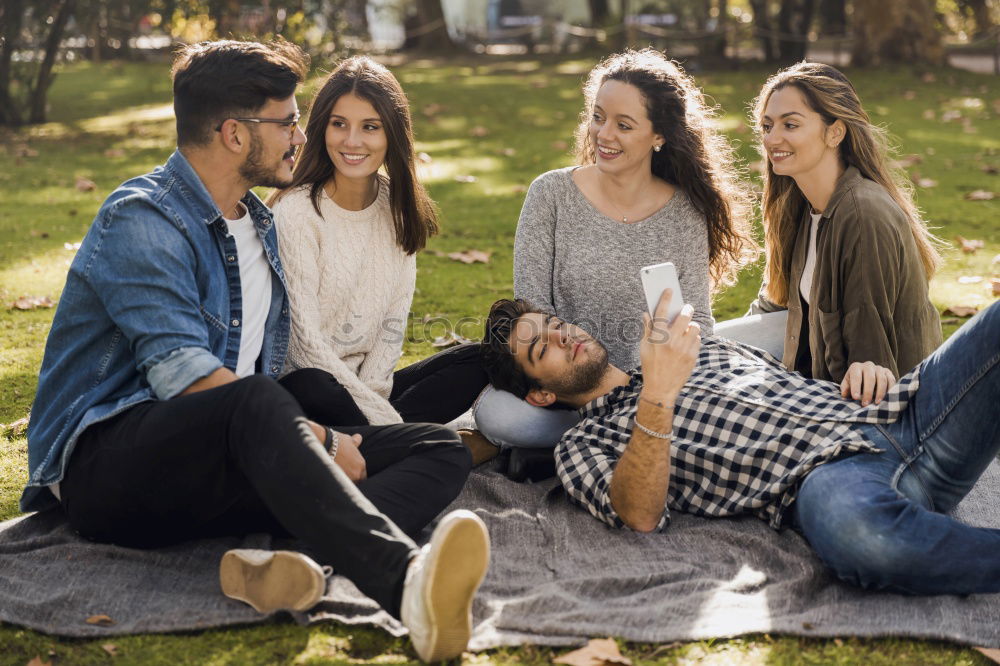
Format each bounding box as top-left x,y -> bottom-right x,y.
226,204 -> 271,377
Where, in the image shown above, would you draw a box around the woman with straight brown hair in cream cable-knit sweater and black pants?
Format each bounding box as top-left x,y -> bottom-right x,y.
268,57 -> 486,425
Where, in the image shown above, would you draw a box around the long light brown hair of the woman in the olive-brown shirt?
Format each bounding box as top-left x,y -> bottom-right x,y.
753,62 -> 941,305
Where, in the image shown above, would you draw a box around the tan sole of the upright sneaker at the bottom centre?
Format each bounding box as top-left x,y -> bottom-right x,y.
420,512 -> 490,662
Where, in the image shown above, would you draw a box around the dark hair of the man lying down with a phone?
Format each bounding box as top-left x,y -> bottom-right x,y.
480,298 -> 542,399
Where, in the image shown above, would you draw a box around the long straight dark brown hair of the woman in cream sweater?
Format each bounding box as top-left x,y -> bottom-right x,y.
267,56 -> 438,254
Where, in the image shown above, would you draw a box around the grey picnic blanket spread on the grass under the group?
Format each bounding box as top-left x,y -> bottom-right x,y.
0,462 -> 1000,649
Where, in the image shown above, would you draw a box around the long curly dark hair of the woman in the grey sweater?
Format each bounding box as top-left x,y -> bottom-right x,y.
576,48 -> 760,290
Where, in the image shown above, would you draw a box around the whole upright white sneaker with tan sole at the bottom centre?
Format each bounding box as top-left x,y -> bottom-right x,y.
401,509 -> 490,662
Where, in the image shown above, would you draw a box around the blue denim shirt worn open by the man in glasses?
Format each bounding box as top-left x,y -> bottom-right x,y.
21,151 -> 289,511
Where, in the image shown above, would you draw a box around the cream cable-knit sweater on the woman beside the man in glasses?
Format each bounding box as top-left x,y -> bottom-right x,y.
274,180 -> 417,425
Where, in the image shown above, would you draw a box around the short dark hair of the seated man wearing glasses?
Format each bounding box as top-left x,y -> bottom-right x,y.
170,38 -> 309,146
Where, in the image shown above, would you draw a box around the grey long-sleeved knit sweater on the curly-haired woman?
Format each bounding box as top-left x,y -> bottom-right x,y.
514,167 -> 715,370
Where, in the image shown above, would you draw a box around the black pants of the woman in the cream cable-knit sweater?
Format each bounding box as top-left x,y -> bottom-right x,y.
282,343 -> 488,425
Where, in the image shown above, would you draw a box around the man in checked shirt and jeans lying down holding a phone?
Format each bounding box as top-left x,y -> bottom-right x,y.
483,290 -> 1000,594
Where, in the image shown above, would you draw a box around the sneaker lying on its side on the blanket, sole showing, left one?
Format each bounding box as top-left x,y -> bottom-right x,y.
219,548 -> 326,613
